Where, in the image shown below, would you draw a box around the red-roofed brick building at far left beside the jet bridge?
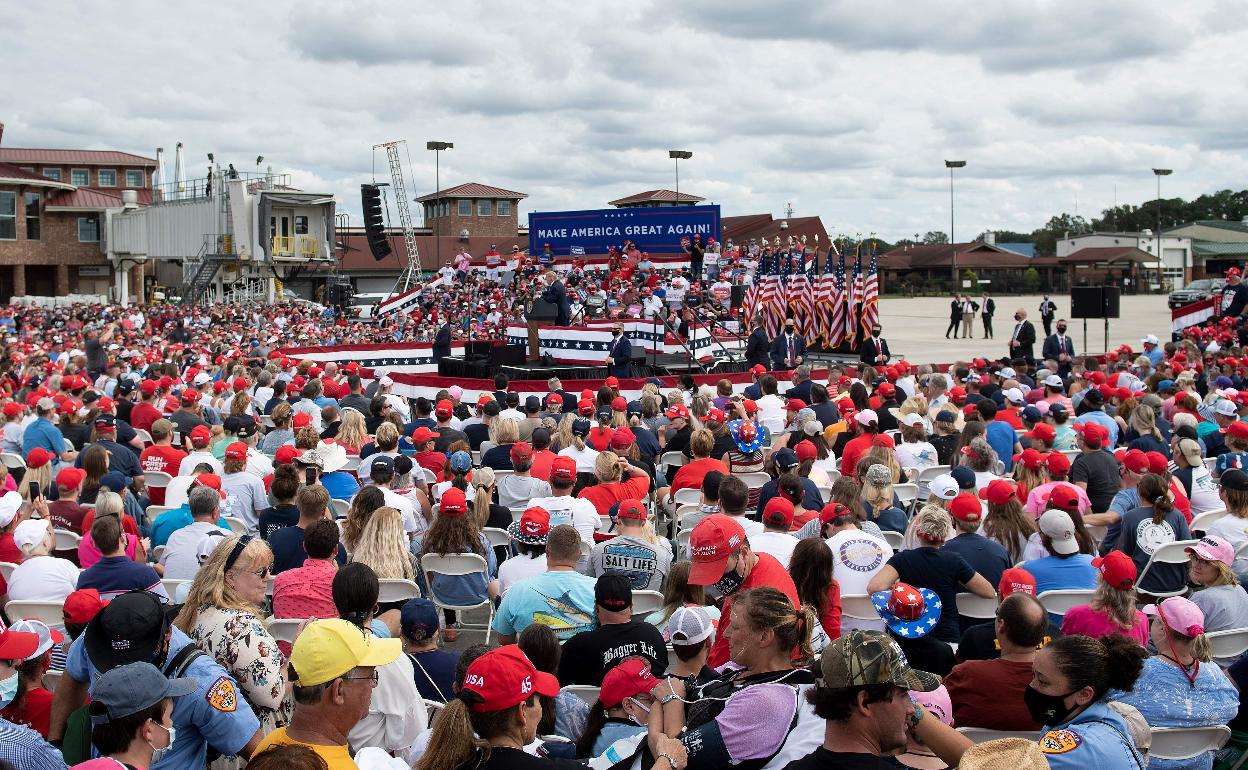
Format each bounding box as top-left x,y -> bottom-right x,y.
0,141 -> 156,302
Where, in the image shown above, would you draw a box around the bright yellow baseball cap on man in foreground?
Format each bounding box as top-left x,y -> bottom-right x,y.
291,618 -> 403,688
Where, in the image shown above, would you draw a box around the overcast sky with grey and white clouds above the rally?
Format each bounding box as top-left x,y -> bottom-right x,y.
0,0 -> 1248,240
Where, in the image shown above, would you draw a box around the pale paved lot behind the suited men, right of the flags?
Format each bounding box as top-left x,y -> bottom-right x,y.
880,295 -> 1171,363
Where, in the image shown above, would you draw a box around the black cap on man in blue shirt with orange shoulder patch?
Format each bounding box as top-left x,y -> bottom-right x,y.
84,590 -> 168,674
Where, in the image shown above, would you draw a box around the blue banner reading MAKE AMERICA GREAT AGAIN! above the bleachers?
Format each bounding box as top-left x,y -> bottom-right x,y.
529,206 -> 720,256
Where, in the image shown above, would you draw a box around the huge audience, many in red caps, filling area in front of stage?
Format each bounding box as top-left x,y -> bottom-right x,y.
0,293 -> 1248,770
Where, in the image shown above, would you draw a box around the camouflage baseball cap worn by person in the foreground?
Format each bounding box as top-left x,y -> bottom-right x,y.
819,630 -> 940,693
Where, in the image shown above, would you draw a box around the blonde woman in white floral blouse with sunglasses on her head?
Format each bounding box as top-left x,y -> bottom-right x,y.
173,535 -> 295,733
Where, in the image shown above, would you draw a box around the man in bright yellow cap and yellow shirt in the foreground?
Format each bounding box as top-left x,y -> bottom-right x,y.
256,618 -> 402,770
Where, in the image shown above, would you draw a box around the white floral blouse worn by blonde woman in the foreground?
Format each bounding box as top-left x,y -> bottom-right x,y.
188,605 -> 295,735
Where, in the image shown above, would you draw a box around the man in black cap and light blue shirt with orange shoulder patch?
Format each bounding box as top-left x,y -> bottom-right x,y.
47,592 -> 263,770
